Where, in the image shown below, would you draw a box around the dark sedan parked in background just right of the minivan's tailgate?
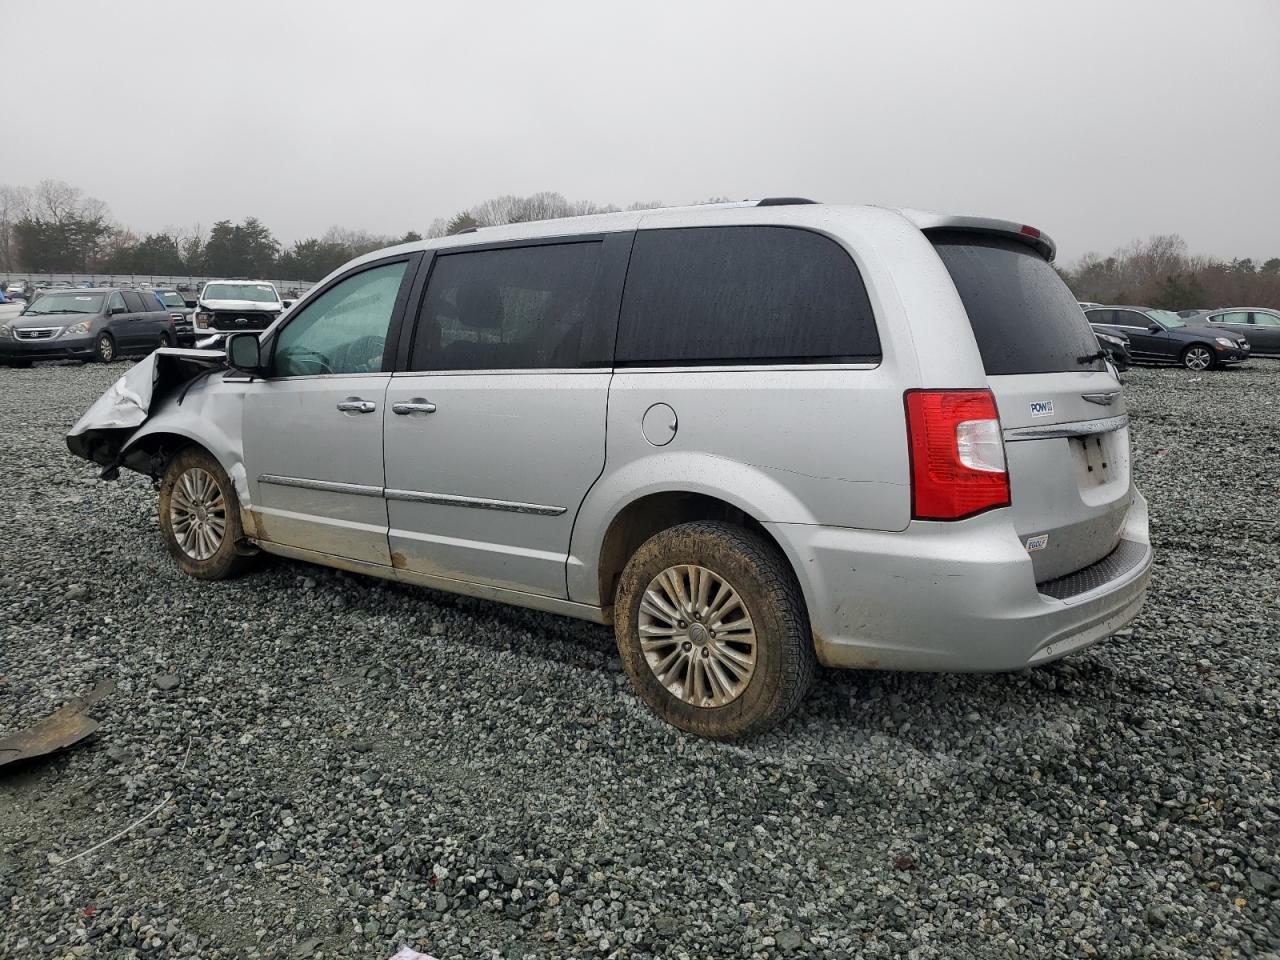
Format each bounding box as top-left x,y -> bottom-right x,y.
1084,306 -> 1249,370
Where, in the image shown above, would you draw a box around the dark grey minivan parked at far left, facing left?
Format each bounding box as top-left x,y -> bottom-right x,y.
0,288 -> 178,366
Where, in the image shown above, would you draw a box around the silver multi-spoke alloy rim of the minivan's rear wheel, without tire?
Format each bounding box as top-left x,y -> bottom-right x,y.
639,563 -> 758,707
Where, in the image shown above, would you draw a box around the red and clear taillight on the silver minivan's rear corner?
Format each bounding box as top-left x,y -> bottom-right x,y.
906,390 -> 1010,520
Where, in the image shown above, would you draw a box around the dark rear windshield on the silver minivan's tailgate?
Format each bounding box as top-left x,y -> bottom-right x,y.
929,232 -> 1106,376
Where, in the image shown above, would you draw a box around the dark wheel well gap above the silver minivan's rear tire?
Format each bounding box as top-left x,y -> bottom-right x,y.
598,492 -> 790,611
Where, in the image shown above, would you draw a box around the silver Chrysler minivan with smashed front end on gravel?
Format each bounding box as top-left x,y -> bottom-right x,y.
68,200 -> 1151,737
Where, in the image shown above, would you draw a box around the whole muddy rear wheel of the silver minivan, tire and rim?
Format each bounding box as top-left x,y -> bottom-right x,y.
614,521 -> 817,740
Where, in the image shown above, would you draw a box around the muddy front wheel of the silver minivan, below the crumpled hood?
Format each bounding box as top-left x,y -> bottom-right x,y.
160,447 -> 248,580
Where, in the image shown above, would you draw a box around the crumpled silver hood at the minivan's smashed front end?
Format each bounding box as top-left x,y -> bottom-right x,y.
67,347 -> 225,470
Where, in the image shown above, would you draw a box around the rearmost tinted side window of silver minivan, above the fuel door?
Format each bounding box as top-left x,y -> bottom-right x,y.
617,227 -> 881,364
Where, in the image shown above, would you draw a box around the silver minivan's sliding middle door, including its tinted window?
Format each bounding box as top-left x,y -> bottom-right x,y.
384,234 -> 631,598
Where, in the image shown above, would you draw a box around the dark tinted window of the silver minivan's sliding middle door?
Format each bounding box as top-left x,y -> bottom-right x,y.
410,241 -> 603,370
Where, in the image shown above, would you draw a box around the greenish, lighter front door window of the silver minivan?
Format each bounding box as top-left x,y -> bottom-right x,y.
273,262 -> 407,376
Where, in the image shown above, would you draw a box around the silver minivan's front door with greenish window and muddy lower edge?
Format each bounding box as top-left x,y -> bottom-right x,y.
242,259 -> 412,566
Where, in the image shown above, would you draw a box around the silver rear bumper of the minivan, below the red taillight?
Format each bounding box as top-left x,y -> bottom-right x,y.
767,492 -> 1152,671
